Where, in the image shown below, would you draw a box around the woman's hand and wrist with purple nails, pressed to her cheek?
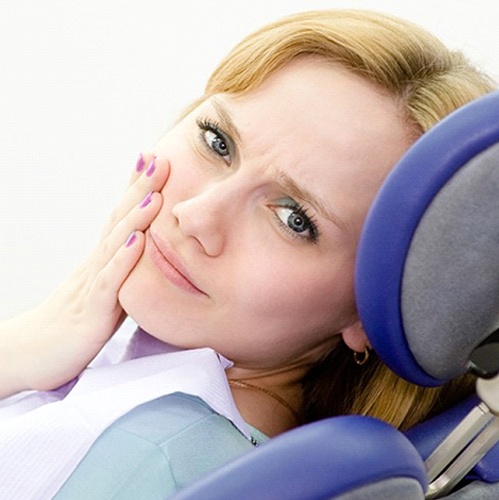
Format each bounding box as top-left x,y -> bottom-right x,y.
0,155 -> 169,397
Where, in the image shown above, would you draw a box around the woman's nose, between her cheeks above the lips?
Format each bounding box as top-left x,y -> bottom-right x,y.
172,187 -> 227,257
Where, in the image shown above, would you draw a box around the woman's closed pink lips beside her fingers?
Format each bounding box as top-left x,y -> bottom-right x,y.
146,230 -> 206,295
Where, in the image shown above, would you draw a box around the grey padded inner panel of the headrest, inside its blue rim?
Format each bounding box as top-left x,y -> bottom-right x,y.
401,144 -> 499,379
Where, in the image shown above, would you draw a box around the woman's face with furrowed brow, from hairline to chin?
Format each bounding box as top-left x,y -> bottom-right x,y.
120,57 -> 410,369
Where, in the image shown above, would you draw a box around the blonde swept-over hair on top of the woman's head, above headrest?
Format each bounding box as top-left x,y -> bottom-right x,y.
190,10 -> 494,132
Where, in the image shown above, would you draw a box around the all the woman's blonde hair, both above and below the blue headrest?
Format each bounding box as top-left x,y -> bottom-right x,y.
189,10 -> 494,428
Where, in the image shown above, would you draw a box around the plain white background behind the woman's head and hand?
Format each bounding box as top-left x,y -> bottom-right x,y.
0,0 -> 499,318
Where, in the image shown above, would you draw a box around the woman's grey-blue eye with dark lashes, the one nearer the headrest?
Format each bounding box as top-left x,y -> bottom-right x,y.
271,198 -> 319,243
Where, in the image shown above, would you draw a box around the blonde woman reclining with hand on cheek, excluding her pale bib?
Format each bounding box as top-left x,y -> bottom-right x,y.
0,11 -> 493,498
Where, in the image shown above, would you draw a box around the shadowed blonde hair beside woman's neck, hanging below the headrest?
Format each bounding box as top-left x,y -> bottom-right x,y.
303,342 -> 475,430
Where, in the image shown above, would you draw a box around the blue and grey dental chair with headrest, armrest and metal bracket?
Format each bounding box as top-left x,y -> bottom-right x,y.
175,92 -> 499,500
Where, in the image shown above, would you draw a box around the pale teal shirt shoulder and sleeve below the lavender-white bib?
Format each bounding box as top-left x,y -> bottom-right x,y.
55,393 -> 267,500
